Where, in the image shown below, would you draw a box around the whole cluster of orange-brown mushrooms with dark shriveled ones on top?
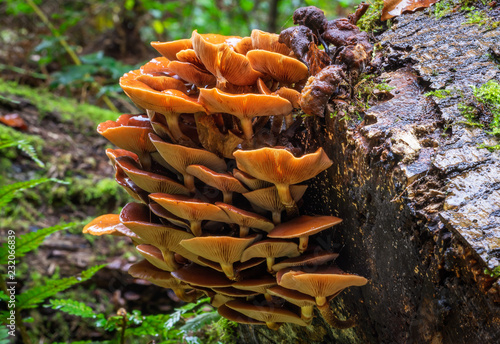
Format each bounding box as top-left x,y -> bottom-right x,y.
84,3 -> 369,329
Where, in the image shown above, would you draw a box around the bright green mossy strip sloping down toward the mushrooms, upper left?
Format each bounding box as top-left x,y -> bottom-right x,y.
0,79 -> 118,127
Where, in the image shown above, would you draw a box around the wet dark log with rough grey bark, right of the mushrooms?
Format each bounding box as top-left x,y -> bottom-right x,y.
238,5 -> 500,344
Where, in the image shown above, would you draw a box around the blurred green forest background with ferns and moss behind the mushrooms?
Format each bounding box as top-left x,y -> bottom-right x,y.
0,0 -> 370,343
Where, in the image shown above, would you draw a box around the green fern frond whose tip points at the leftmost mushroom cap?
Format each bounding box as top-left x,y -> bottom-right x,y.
0,222 -> 77,264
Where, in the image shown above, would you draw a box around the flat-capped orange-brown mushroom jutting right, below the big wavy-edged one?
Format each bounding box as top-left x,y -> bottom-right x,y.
268,215 -> 342,252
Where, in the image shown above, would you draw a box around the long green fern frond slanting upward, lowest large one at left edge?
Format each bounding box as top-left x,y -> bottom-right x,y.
16,264 -> 105,311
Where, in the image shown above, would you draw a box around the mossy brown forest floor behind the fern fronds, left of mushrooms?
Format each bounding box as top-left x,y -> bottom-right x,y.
0,80 -> 184,343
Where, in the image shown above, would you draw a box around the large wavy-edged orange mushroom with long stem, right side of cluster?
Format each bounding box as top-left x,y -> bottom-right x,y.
233,148 -> 333,214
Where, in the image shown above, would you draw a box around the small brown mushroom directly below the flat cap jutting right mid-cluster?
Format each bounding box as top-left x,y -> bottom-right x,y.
241,239 -> 300,273
